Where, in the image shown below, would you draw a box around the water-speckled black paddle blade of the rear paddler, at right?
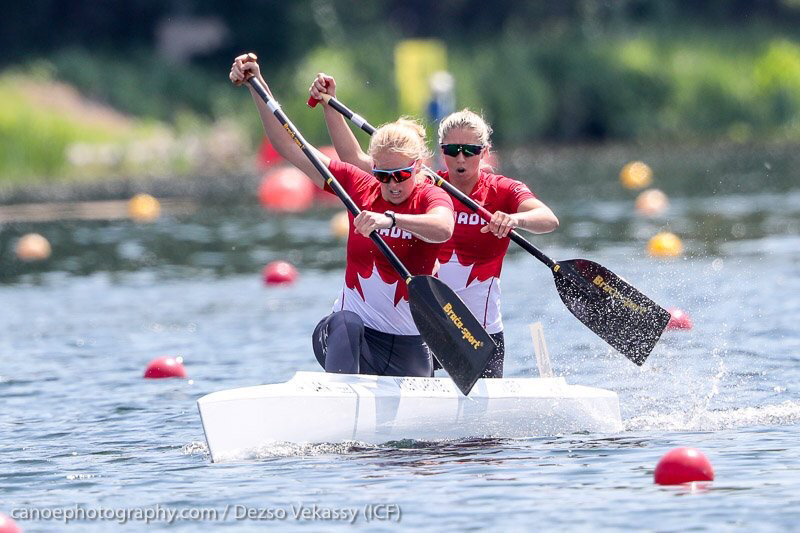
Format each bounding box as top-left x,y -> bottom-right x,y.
553,259 -> 669,366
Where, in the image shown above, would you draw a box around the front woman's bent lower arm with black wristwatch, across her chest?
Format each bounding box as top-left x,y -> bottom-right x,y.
353,206 -> 455,242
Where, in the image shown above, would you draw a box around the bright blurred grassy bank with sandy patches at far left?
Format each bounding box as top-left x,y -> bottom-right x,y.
0,52 -> 251,185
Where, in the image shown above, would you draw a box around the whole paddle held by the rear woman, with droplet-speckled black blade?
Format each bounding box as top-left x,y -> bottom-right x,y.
308,94 -> 670,366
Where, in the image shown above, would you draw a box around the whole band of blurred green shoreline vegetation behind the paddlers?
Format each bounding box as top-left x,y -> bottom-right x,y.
0,0 -> 800,184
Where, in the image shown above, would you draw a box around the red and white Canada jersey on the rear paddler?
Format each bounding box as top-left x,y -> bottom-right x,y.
438,171 -> 535,333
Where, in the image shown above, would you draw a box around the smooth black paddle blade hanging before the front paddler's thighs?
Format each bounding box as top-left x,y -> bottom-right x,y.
408,276 -> 496,396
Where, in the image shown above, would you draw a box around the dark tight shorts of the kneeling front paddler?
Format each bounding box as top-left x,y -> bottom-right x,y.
311,311 -> 433,377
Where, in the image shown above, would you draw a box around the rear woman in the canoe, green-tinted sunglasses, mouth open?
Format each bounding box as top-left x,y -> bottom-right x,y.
309,74 -> 558,378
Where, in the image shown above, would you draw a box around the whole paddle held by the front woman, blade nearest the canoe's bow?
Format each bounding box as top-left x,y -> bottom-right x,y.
242,57 -> 496,395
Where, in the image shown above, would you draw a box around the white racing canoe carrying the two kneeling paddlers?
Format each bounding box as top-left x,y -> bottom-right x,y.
197,372 -> 622,461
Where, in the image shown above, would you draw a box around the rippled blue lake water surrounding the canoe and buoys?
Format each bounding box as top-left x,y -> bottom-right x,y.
0,145 -> 800,532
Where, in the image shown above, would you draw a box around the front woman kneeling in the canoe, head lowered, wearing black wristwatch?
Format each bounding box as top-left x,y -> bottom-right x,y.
229,54 -> 454,376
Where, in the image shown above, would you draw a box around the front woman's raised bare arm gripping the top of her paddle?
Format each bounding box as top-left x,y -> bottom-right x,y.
229,54 -> 331,188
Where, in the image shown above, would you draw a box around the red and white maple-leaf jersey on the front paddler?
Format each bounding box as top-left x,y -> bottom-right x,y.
325,159 -> 453,335
